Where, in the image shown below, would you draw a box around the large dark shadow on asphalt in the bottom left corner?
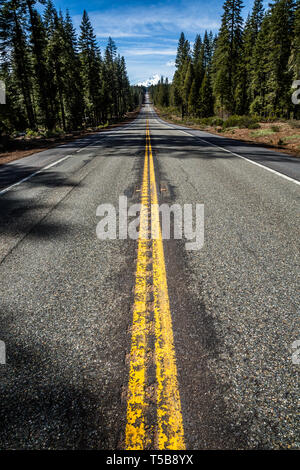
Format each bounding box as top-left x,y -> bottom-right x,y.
0,303 -> 122,449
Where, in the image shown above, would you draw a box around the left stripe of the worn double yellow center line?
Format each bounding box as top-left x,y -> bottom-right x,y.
125,132 -> 149,450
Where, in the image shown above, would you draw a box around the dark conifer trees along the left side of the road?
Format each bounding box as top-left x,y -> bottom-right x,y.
0,0 -> 141,132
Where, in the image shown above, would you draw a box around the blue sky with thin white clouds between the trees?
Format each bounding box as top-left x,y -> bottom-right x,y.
42,0 -> 268,84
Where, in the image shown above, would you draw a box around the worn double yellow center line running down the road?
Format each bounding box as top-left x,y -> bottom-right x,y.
125,121 -> 185,450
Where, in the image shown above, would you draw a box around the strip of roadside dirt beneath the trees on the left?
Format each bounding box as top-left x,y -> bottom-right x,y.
0,109 -> 140,165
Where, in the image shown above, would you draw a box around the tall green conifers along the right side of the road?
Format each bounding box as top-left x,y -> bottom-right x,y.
151,0 -> 300,118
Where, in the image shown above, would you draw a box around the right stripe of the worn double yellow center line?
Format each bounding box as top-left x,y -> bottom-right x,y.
147,120 -> 185,450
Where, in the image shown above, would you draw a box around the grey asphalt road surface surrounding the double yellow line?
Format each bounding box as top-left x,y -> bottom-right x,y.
0,101 -> 300,449
